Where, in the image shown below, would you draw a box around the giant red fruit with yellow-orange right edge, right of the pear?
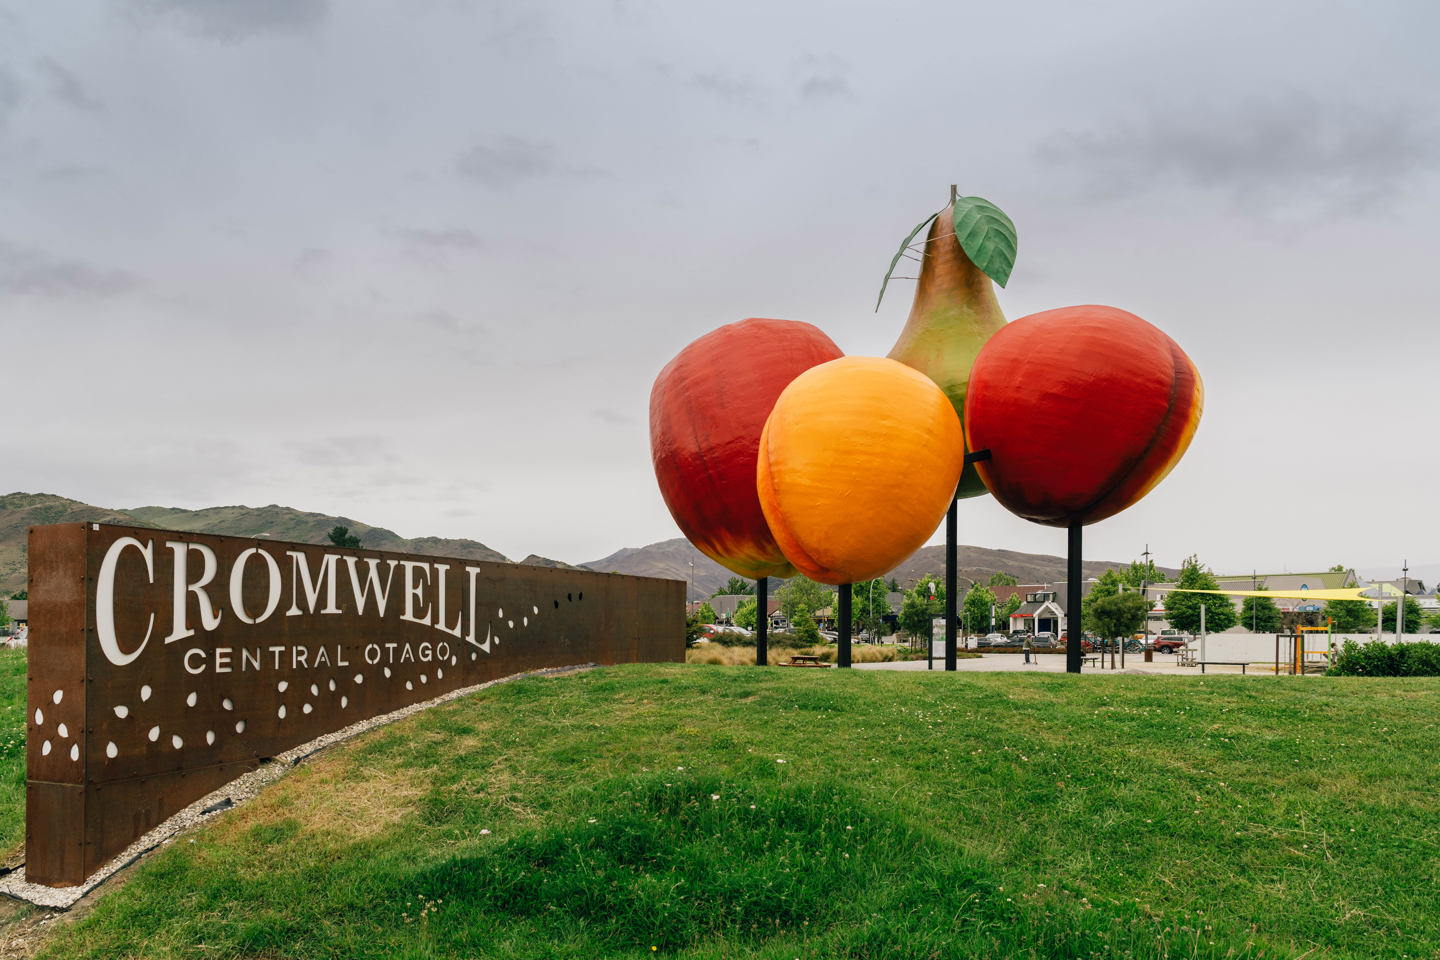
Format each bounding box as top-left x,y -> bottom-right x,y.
965,307 -> 1205,527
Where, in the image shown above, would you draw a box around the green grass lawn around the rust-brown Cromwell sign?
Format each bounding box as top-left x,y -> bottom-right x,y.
0,661 -> 1440,959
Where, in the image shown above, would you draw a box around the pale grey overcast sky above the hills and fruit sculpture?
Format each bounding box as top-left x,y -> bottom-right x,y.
0,0 -> 1440,579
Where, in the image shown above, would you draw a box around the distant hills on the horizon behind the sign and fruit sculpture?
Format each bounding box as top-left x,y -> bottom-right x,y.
0,494 -> 1178,599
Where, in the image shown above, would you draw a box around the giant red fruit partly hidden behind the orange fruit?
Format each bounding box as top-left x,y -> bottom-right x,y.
649,318 -> 844,580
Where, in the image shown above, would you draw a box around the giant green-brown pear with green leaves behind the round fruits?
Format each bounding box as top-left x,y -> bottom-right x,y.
877,197 -> 1015,498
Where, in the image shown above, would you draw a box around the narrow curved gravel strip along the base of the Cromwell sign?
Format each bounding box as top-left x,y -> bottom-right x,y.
0,664 -> 595,910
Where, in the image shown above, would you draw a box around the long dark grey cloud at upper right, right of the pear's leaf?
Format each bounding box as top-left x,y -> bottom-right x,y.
1038,95 -> 1440,219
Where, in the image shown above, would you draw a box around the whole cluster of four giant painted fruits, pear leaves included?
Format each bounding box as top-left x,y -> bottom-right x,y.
649,187 -> 1204,613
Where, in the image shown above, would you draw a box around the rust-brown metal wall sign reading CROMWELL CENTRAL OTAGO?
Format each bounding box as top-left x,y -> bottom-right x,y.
26,524 -> 684,887
